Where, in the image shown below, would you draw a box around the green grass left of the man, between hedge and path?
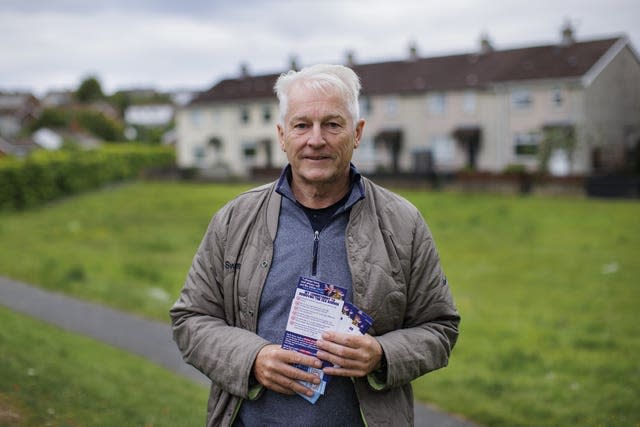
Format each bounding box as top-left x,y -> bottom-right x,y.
0,183 -> 252,321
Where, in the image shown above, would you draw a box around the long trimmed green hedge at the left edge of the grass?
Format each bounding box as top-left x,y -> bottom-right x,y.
0,144 -> 175,210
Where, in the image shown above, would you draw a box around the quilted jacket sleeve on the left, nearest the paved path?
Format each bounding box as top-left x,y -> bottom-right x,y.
170,209 -> 269,398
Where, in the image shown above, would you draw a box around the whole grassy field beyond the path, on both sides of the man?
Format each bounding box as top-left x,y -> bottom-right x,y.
0,182 -> 640,426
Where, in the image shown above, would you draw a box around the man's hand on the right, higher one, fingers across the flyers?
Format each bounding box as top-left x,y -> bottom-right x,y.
316,332 -> 383,377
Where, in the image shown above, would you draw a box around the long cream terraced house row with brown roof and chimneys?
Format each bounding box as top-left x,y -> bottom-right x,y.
176,25 -> 640,176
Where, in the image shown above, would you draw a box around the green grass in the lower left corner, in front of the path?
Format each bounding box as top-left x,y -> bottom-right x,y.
0,308 -> 208,427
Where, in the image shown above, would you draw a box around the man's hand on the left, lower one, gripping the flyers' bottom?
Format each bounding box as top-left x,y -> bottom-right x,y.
253,344 -> 322,396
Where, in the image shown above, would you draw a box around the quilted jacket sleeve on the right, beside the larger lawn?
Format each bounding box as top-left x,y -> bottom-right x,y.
376,210 -> 460,389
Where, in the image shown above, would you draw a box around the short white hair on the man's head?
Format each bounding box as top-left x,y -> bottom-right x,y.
274,64 -> 361,127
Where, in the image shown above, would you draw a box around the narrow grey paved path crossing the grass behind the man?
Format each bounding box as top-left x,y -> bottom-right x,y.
0,276 -> 476,427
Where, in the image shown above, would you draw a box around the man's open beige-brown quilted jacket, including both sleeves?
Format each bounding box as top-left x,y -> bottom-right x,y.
170,178 -> 460,426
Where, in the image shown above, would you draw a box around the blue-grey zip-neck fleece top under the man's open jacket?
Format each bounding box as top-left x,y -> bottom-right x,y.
234,167 -> 364,427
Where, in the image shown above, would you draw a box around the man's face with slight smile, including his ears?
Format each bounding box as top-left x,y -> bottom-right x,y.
278,84 -> 364,185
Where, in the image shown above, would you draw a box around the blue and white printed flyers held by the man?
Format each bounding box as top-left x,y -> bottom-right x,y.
282,277 -> 373,403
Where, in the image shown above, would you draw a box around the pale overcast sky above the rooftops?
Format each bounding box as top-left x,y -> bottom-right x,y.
0,0 -> 640,95
